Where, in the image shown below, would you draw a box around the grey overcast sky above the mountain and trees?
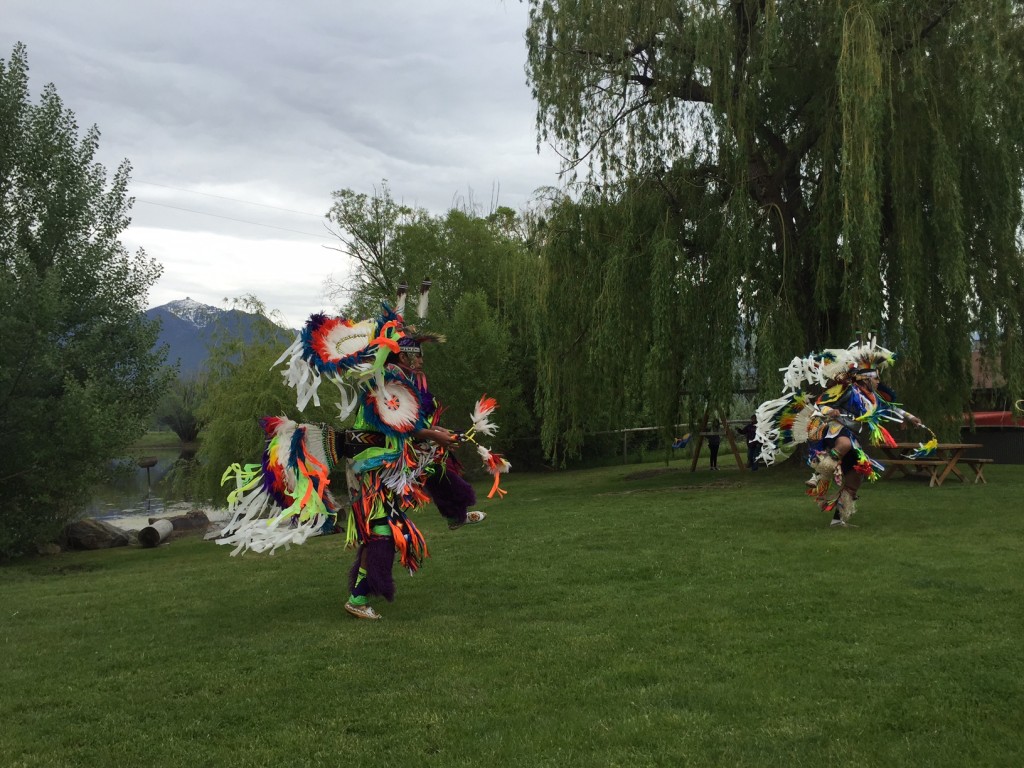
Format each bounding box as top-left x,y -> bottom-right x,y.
0,0 -> 558,327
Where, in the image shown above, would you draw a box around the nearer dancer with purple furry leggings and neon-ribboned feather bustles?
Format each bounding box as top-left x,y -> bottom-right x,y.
210,282 -> 510,620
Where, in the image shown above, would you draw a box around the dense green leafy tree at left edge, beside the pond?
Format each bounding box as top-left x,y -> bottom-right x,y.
0,45 -> 172,556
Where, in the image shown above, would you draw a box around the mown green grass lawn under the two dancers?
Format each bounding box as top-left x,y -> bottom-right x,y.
0,461 -> 1024,768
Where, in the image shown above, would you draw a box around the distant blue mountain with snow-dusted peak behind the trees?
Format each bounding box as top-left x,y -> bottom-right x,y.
145,296 -> 296,377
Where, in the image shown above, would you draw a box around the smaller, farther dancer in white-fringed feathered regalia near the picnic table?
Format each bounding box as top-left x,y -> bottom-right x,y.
756,338 -> 936,527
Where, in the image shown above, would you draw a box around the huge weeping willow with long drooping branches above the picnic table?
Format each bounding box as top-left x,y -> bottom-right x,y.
526,0 -> 1024,460
